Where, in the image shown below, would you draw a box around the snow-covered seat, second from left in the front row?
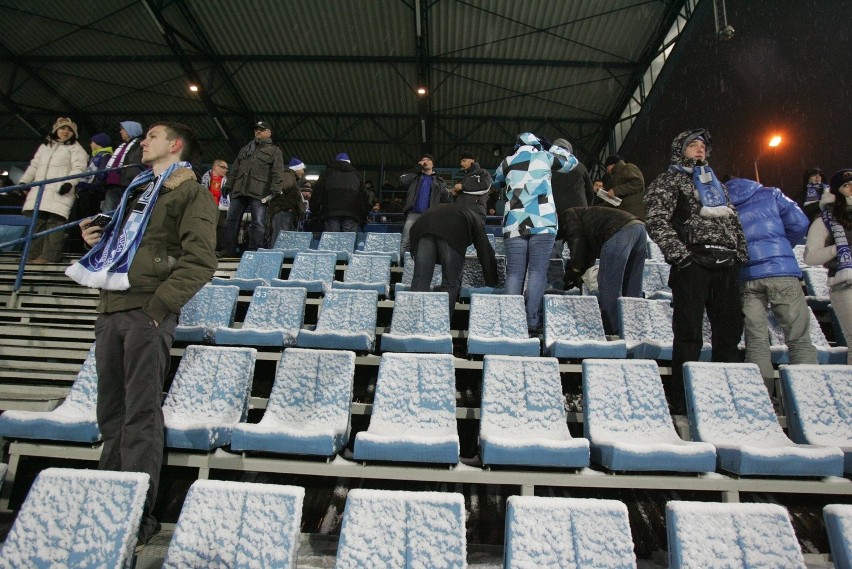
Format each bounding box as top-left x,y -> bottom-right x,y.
163,480 -> 305,569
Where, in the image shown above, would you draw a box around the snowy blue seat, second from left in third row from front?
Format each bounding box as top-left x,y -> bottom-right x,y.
216,286 -> 308,347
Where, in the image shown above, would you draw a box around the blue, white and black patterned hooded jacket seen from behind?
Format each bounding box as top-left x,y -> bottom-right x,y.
494,132 -> 577,238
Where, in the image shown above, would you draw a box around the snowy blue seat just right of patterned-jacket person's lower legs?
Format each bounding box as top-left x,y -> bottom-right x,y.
544,294 -> 627,359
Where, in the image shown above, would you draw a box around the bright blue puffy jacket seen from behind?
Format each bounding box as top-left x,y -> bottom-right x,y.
725,178 -> 808,281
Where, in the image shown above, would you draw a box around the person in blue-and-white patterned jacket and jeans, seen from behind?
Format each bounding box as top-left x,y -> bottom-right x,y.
494,132 -> 577,334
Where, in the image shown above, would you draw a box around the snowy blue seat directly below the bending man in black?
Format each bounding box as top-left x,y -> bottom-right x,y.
382,292 -> 453,354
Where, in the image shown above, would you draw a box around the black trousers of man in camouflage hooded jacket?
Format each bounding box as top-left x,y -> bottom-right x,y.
669,263 -> 743,409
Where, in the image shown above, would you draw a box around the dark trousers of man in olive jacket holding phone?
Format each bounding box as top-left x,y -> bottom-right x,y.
95,309 -> 177,523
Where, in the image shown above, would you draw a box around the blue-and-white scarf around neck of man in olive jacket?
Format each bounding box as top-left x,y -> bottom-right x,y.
65,162 -> 192,290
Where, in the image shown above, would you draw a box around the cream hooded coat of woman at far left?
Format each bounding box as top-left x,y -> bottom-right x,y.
19,140 -> 89,219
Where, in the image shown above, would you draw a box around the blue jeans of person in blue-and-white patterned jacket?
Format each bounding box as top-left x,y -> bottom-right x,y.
503,233 -> 556,330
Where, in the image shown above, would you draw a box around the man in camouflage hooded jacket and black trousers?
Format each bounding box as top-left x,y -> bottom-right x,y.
645,128 -> 748,413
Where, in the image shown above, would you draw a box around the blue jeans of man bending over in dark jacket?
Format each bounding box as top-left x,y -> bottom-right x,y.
598,223 -> 648,334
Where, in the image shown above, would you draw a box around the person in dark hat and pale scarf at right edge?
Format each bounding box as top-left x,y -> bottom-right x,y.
805,168 -> 852,364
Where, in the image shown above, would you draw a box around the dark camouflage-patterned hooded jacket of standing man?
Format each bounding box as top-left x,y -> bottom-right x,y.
645,129 -> 748,266
